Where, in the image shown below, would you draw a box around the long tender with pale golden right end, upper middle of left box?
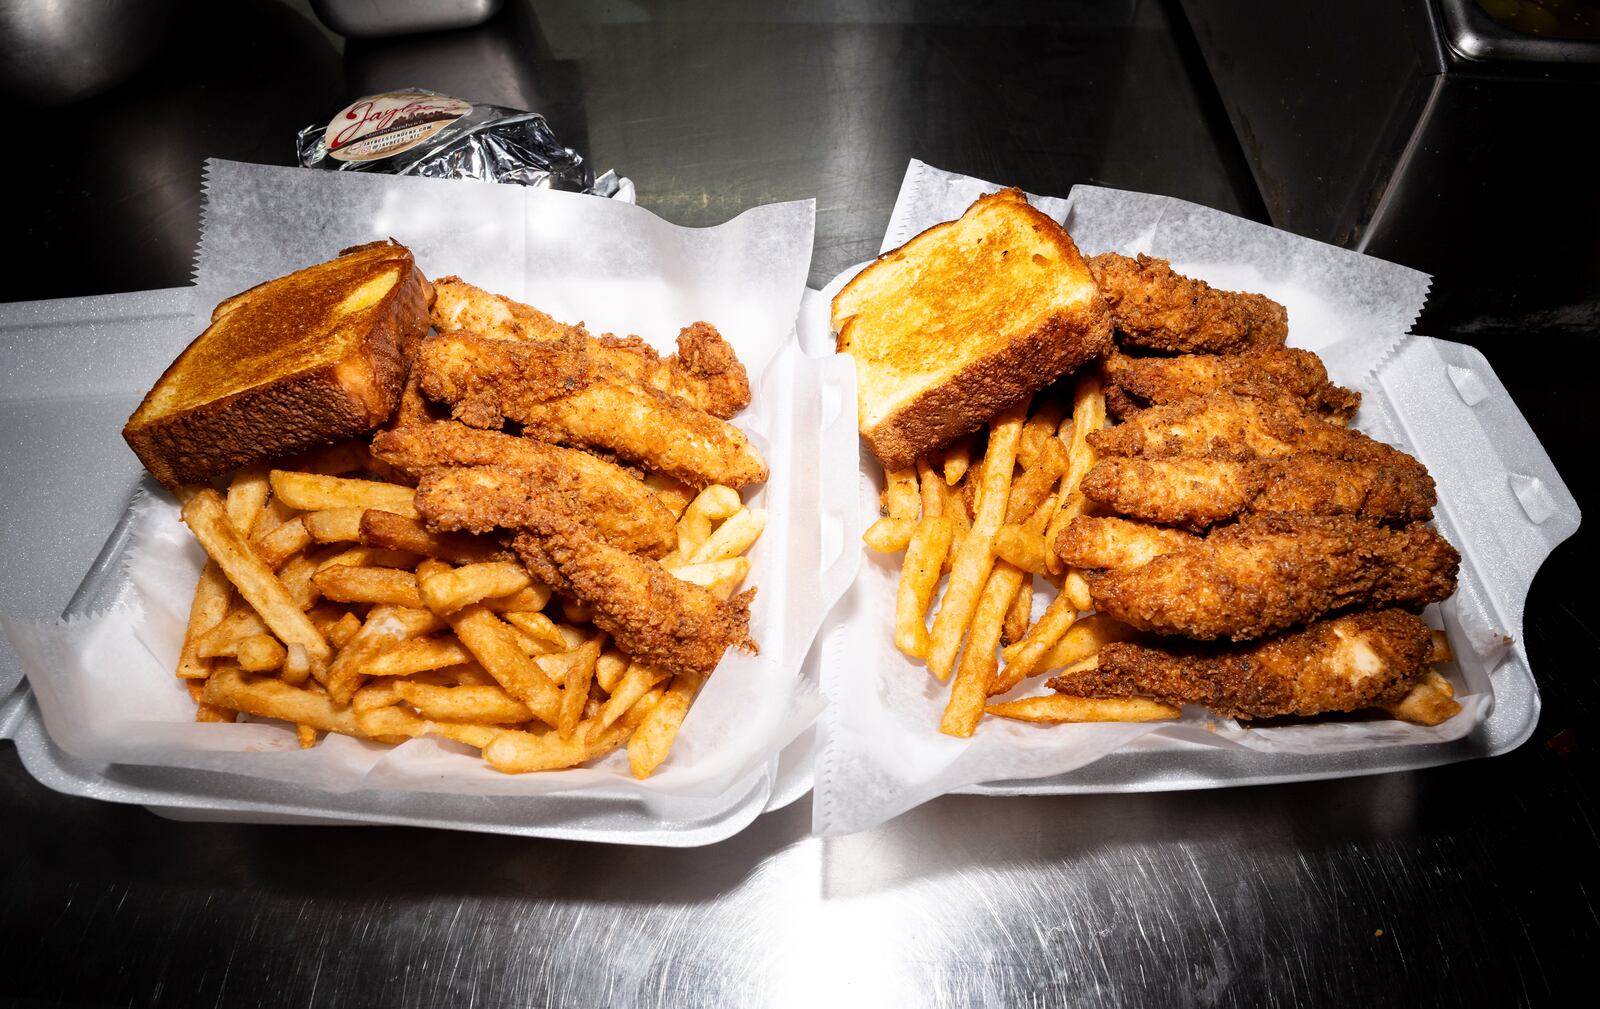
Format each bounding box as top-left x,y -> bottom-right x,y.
414,333 -> 766,488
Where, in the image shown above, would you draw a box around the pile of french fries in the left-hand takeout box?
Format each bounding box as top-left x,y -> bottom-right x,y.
178,441 -> 765,779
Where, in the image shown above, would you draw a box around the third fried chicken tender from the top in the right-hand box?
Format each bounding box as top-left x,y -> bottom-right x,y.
1090,389 -> 1403,462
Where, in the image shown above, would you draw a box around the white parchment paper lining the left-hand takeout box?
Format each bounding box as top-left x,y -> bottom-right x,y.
5,162 -> 854,843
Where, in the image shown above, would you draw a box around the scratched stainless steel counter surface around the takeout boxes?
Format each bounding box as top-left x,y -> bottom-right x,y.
0,0 -> 1600,1007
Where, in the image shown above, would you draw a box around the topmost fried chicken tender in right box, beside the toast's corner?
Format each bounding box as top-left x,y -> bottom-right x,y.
1090,253 -> 1288,353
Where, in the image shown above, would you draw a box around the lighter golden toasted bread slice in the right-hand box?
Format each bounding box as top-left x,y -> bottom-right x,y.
834,189 -> 1110,469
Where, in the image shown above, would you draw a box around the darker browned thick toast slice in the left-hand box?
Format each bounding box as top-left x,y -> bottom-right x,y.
122,241 -> 432,488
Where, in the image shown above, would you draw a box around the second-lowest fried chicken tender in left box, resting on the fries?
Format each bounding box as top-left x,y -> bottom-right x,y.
416,463 -> 677,556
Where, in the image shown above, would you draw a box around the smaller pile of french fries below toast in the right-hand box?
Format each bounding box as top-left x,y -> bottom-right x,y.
862,374 -> 1179,737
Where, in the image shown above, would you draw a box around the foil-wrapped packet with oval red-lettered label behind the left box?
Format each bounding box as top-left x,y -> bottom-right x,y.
298,88 -> 634,203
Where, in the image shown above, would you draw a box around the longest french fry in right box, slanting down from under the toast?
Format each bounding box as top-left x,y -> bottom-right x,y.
928,405 -> 1026,689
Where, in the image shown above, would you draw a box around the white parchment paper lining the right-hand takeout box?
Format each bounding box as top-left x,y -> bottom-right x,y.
812,162 -> 1497,835
